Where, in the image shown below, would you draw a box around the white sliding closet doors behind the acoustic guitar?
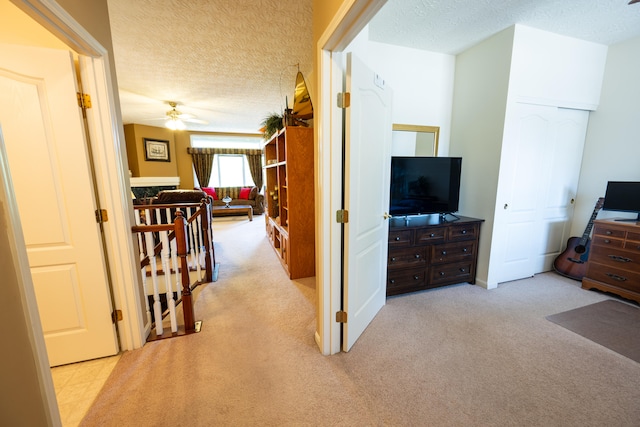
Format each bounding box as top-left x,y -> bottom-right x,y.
490,104 -> 589,283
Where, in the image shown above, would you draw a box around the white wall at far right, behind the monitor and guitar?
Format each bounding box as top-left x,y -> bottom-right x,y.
571,37 -> 640,232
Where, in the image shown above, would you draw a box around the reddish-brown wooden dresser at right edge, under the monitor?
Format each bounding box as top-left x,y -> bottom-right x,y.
582,219 -> 640,302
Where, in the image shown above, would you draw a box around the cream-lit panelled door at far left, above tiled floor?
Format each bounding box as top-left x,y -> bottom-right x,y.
0,45 -> 118,366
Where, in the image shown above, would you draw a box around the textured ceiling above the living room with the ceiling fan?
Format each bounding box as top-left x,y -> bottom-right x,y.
108,0 -> 312,133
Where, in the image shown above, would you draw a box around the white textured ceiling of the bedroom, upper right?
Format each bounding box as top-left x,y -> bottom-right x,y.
369,0 -> 640,54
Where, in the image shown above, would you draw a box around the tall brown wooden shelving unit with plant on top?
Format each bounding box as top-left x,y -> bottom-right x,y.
263,126 -> 315,279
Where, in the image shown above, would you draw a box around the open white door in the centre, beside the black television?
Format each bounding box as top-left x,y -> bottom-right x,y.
342,54 -> 392,351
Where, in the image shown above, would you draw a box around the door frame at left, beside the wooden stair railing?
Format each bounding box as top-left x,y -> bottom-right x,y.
11,0 -> 148,350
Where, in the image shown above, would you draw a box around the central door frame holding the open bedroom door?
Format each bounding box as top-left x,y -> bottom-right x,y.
314,0 -> 386,355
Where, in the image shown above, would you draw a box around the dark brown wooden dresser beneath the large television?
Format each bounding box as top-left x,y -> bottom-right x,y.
387,215 -> 484,296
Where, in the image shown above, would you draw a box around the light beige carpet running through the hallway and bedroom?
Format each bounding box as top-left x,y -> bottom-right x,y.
81,216 -> 640,426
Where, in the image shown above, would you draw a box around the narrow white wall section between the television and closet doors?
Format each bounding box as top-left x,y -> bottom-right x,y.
449,27 -> 514,287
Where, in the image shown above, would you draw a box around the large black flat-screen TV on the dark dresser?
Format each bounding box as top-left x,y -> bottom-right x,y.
389,157 -> 462,216
